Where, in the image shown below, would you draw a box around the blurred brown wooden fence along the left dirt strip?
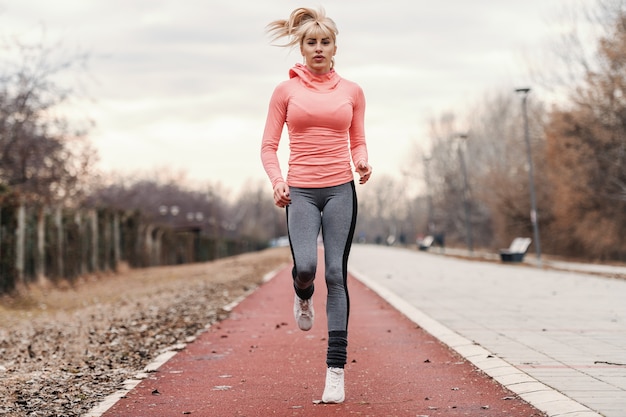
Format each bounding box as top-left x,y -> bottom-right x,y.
0,201 -> 262,294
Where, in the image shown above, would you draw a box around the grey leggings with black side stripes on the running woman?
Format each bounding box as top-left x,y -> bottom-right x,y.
287,181 -> 357,368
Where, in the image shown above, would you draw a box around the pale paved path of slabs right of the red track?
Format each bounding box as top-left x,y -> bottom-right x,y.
350,245 -> 626,417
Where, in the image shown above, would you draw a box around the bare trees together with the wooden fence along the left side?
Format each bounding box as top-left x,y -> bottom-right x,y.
0,35 -> 267,293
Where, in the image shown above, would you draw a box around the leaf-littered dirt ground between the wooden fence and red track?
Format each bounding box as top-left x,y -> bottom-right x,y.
0,248 -> 290,417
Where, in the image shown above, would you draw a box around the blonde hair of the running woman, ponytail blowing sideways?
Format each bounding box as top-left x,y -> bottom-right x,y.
266,7 -> 339,47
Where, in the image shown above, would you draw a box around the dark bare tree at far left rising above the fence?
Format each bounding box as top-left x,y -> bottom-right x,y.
0,34 -> 97,204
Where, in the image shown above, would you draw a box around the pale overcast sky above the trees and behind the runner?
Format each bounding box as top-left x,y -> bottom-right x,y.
0,0 -> 575,192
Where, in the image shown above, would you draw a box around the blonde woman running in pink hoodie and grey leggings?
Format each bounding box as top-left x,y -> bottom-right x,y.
261,8 -> 372,403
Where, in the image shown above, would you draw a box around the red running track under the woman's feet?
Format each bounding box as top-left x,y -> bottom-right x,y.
90,254 -> 543,417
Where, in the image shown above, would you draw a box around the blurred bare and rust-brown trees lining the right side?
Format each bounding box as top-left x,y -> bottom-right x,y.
404,1 -> 626,261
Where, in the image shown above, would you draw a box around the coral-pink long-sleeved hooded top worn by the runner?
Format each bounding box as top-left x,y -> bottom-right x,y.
261,64 -> 367,188
